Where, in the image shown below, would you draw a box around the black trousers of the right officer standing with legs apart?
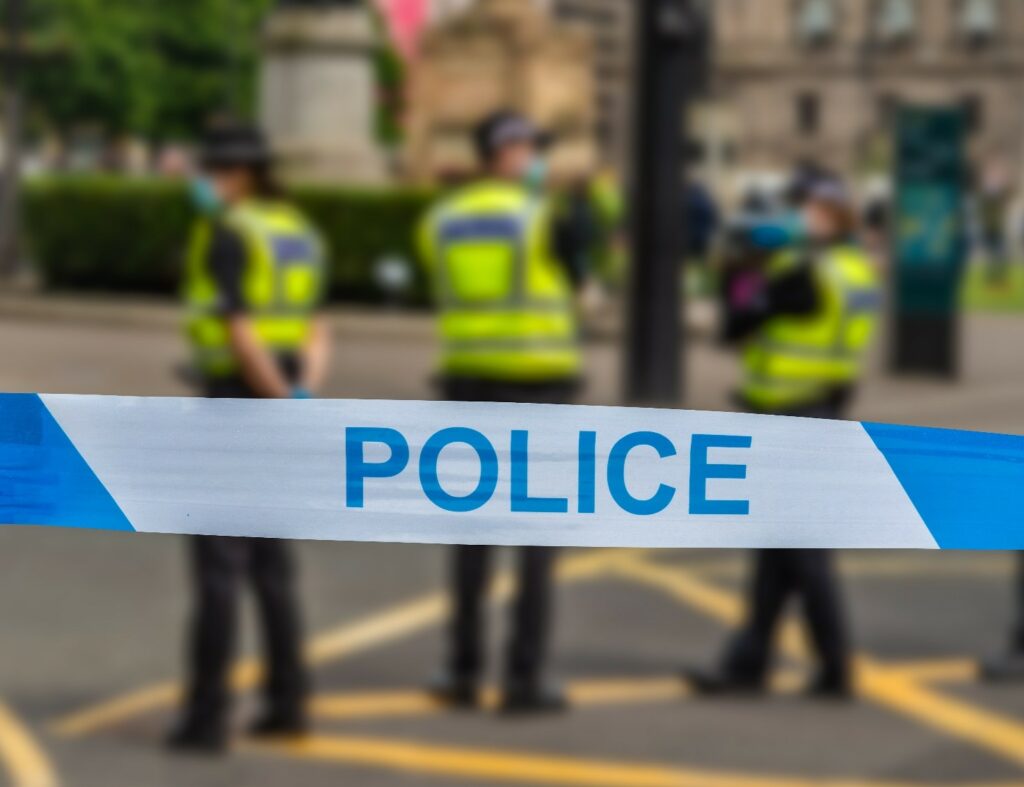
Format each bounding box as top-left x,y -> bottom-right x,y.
724,403 -> 850,681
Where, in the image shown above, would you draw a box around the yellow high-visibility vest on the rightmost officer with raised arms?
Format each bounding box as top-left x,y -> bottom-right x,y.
740,246 -> 881,412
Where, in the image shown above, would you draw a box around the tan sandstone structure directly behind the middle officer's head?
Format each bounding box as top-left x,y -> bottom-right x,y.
406,0 -> 598,181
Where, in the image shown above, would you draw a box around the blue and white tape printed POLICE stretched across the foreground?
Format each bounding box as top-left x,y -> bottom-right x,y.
0,394 -> 1024,550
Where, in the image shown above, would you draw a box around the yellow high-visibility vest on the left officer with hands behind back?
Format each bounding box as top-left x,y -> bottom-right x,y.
183,201 -> 324,377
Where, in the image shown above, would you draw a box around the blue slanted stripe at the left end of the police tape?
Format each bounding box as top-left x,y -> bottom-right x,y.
0,394 -> 134,530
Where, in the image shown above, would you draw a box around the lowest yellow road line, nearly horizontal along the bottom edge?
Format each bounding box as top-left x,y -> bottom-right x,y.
251,736 -> 1019,787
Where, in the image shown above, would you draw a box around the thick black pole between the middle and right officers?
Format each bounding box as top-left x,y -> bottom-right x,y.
626,0 -> 707,406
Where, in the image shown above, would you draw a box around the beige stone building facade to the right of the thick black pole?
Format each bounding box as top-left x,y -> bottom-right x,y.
700,0 -> 1024,187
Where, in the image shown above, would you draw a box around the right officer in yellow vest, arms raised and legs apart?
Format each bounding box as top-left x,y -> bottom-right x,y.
685,178 -> 880,698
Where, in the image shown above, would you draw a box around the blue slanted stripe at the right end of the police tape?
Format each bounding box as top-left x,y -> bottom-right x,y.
863,423 -> 1024,550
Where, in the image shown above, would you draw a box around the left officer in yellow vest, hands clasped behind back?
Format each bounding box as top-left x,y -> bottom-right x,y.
168,125 -> 329,751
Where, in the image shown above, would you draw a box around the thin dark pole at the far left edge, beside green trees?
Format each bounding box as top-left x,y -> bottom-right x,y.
0,0 -> 25,277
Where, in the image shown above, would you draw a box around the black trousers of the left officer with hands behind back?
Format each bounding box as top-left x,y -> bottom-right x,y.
186,380 -> 308,726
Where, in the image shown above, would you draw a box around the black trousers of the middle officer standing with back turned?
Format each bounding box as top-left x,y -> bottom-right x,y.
442,379 -> 575,682
